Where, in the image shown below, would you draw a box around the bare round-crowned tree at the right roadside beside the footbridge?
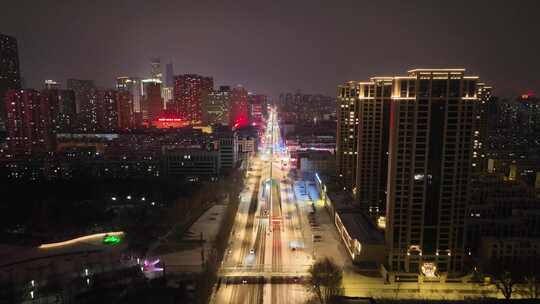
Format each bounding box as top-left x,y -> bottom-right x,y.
306,258 -> 343,304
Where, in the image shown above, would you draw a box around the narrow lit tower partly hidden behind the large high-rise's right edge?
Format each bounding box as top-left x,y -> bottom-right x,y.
472,82 -> 492,173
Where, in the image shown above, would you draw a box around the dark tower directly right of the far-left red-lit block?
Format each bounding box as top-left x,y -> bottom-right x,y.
41,88 -> 76,133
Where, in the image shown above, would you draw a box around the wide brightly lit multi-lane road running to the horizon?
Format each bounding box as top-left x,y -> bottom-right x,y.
213,110 -> 313,303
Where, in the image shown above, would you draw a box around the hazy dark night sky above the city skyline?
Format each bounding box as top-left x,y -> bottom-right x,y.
0,0 -> 540,97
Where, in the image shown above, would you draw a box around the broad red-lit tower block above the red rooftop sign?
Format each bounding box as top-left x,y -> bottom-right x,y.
171,74 -> 214,125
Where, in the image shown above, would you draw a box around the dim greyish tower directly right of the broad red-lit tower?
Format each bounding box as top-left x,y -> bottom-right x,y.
203,86 -> 231,126
